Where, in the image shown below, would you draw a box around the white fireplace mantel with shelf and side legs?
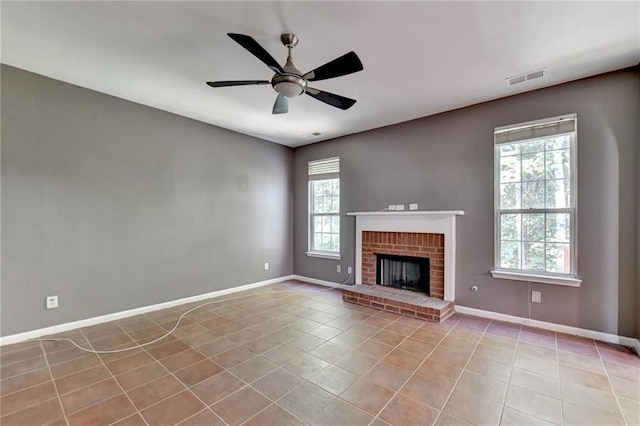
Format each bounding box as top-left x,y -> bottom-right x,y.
347,210 -> 464,302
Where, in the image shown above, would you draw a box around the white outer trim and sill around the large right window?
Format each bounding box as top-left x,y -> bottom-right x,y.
490,114 -> 582,287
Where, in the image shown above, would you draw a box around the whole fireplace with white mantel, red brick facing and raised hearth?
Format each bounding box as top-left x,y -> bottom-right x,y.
342,211 -> 464,321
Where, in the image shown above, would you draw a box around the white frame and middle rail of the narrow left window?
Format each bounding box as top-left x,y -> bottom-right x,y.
306,157 -> 342,260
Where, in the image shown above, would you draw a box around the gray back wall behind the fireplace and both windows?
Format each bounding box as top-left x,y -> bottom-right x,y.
294,70 -> 640,336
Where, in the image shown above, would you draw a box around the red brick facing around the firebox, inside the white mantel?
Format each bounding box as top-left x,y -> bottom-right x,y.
361,231 -> 444,299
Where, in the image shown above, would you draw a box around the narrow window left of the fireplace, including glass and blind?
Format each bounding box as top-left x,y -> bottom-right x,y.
307,157 -> 340,259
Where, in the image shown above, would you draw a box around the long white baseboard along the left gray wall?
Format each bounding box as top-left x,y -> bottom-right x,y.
0,275 -> 297,346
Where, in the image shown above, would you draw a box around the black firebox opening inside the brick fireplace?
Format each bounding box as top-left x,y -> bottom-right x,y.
376,253 -> 429,295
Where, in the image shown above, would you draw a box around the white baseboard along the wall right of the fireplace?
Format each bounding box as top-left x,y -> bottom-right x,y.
456,305 -> 640,354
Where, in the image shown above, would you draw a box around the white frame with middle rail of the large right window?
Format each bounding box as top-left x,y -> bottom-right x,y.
491,114 -> 582,287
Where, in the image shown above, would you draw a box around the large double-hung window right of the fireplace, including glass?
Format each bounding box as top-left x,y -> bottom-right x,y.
492,114 -> 580,286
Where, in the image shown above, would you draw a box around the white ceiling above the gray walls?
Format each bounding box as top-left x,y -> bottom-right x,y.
0,1 -> 640,147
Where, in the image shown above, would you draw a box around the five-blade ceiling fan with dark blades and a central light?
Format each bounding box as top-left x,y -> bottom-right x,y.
207,33 -> 363,114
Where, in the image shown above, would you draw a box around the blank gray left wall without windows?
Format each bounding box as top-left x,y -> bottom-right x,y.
0,66 -> 293,335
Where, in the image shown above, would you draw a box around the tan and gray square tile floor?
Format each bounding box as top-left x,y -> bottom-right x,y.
0,282 -> 640,426
